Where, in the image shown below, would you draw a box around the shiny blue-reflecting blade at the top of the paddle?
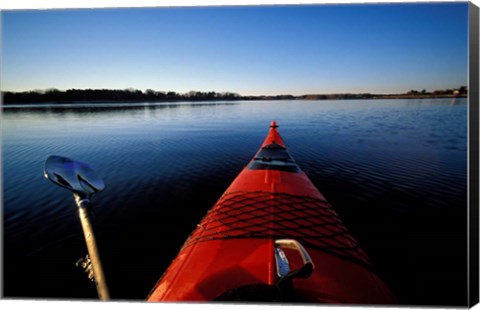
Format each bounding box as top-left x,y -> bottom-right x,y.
44,155 -> 105,195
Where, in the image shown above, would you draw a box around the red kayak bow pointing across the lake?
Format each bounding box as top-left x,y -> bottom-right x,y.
147,122 -> 396,304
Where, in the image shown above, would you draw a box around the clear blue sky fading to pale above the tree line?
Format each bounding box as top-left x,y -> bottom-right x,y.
1,2 -> 468,95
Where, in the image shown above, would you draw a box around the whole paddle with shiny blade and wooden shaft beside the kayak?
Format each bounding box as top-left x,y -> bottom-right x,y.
44,156 -> 110,300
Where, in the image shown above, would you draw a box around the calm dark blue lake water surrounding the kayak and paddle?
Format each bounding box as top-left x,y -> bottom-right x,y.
2,99 -> 468,305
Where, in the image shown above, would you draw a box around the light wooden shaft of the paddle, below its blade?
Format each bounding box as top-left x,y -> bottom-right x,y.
75,195 -> 110,300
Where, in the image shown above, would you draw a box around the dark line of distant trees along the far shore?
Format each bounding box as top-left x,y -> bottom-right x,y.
2,86 -> 468,104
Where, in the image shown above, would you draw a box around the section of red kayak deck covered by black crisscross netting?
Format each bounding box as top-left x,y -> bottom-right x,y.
184,191 -> 369,264
